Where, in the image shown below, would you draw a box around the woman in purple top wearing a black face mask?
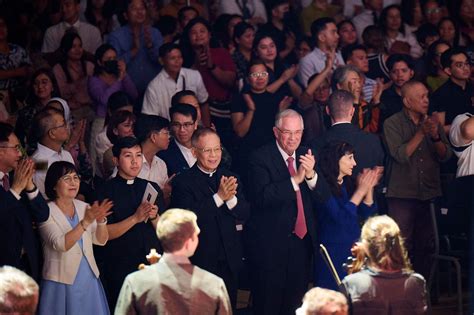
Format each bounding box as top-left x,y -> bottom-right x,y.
87,44 -> 138,174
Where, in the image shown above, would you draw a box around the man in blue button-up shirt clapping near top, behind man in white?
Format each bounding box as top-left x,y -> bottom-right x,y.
107,0 -> 163,97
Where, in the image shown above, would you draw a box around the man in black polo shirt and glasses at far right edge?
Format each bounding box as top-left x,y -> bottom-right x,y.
431,48 -> 474,132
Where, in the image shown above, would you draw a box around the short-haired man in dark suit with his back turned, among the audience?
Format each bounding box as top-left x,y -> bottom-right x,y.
311,90 -> 384,176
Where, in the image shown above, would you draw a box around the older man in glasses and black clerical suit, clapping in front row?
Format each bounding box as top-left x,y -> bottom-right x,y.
171,128 -> 250,307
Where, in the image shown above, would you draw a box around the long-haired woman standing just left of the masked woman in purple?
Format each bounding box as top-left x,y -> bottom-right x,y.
53,32 -> 94,123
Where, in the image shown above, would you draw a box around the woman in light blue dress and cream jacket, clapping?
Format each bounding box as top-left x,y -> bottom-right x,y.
39,161 -> 112,315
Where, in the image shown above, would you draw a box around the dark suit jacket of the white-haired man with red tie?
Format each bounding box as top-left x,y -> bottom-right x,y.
246,142 -> 317,268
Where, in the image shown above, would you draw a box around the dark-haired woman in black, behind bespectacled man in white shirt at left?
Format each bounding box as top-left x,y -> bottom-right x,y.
15,68 -> 58,145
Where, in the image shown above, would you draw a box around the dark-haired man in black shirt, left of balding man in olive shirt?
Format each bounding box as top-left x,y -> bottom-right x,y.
379,54 -> 415,126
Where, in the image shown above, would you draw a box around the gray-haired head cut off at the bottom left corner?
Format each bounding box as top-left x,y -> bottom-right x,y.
0,266 -> 39,314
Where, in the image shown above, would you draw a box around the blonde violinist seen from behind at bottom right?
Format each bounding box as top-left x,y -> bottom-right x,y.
342,215 -> 427,315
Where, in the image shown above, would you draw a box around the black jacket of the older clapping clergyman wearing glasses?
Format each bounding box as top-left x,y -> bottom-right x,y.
171,164 -> 250,274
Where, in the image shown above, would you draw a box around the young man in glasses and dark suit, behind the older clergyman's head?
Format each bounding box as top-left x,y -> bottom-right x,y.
158,104 -> 197,176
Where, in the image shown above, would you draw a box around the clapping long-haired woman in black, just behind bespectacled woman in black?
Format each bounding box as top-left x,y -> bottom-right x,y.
253,33 -> 302,100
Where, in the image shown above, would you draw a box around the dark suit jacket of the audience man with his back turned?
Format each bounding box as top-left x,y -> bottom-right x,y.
311,123 -> 385,175
